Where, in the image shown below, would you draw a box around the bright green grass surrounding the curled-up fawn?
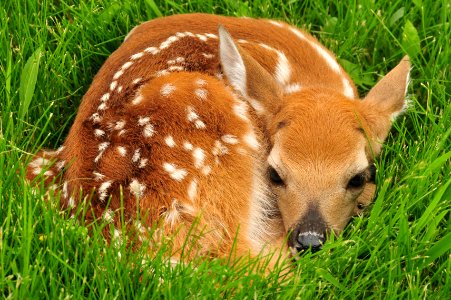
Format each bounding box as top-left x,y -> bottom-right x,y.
0,0 -> 451,299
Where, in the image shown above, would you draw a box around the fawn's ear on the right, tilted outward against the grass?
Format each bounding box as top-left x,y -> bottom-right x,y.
362,56 -> 410,141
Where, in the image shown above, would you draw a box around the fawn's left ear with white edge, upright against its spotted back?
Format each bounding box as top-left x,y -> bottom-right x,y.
219,26 -> 282,114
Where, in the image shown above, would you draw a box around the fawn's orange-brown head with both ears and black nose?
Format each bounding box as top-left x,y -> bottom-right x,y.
219,27 -> 410,253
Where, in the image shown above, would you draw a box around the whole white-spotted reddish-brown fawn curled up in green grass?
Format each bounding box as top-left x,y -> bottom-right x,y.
28,14 -> 410,262
